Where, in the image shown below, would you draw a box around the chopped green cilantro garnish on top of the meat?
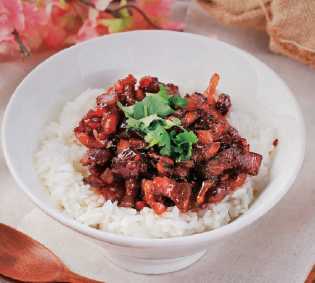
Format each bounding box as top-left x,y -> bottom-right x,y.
118,85 -> 198,161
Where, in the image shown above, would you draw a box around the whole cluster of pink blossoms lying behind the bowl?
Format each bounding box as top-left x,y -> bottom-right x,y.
0,0 -> 182,59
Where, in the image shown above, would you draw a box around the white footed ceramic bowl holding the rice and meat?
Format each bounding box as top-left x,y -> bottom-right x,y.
2,31 -> 305,274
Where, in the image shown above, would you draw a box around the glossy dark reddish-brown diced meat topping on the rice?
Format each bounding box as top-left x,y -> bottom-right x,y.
74,74 -> 262,214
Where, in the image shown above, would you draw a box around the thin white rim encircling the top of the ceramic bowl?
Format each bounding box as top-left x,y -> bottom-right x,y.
1,30 -> 306,247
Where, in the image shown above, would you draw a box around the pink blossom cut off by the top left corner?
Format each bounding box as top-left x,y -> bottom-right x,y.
0,0 -> 24,37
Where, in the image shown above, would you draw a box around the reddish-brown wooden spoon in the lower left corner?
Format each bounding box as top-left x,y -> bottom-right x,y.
0,223 -> 101,283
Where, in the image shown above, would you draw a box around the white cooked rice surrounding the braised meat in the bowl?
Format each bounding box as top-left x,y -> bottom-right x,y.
34,89 -> 275,238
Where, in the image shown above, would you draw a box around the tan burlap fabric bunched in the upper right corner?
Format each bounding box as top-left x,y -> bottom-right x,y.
197,0 -> 315,67
